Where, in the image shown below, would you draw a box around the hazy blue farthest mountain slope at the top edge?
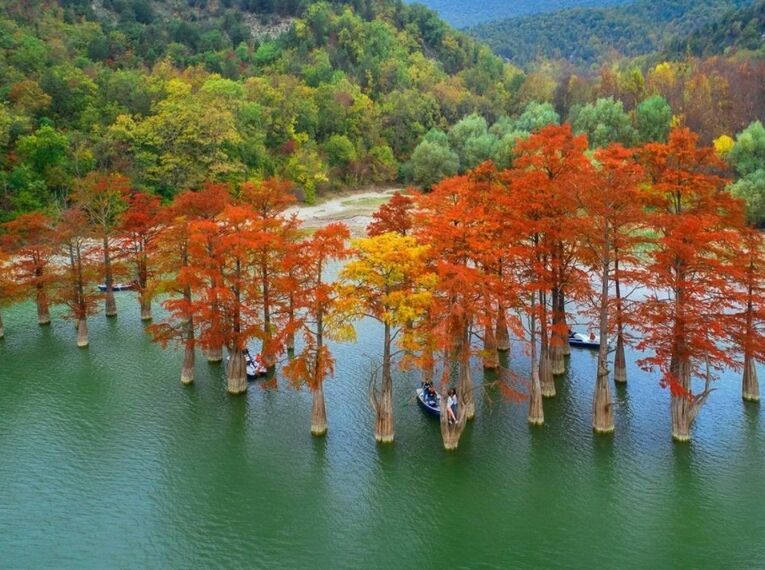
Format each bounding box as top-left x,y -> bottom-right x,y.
400,0 -> 629,28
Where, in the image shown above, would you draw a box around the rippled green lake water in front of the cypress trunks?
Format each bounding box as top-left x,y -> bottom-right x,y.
0,294 -> 765,569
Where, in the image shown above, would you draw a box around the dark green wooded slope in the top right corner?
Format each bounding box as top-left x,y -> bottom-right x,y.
669,1 -> 765,57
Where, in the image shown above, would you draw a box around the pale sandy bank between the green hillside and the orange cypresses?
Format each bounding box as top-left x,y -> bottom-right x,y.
287,188 -> 401,231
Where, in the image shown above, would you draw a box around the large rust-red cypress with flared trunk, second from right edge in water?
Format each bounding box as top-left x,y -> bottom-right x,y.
638,129 -> 744,441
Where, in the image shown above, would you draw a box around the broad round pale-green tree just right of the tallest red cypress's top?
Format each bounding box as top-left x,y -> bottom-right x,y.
570,97 -> 637,148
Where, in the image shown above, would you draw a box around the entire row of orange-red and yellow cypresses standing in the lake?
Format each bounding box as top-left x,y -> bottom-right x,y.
0,124 -> 765,449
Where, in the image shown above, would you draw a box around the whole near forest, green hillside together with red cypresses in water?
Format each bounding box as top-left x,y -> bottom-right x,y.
0,0 -> 765,449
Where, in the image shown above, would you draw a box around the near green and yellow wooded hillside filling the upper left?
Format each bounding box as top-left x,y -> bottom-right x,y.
0,0 -> 523,218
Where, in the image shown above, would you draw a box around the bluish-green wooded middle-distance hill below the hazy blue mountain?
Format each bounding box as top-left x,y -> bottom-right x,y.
468,0 -> 751,66
